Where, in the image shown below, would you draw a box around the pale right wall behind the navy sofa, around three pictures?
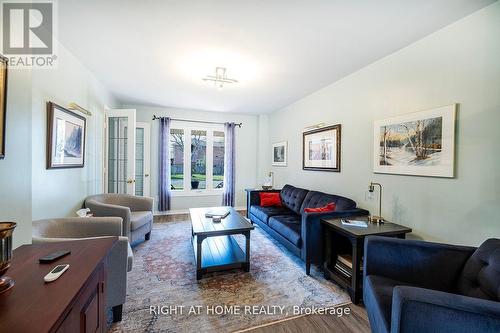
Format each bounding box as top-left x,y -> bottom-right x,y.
261,3 -> 500,245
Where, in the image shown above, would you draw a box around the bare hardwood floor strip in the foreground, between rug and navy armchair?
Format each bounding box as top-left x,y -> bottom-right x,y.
244,304 -> 370,333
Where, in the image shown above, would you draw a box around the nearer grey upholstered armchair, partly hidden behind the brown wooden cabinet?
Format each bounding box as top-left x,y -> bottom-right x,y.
32,217 -> 133,322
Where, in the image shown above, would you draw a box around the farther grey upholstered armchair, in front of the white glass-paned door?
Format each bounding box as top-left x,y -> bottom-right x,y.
85,193 -> 153,244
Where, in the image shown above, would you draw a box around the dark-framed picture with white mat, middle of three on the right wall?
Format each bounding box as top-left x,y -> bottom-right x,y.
302,125 -> 341,172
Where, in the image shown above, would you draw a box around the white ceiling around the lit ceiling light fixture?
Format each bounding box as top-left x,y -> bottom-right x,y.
58,0 -> 494,113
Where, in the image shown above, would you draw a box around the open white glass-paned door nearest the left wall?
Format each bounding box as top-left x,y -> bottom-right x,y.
105,109 -> 136,195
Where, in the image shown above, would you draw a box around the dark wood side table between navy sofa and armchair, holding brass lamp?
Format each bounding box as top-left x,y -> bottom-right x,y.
321,216 -> 411,304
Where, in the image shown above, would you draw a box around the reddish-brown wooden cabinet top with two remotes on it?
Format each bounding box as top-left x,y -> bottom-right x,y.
0,237 -> 118,332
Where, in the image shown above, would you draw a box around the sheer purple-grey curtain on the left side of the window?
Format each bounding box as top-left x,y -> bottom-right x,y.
158,117 -> 171,212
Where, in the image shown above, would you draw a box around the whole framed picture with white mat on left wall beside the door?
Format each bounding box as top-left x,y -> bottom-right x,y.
47,102 -> 86,169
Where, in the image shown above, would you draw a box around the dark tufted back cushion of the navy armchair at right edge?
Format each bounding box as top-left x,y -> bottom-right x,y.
458,238 -> 500,302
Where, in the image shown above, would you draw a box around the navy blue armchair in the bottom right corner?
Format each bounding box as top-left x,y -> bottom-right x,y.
363,236 -> 500,333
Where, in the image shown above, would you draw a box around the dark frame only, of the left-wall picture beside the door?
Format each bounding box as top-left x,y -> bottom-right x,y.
47,102 -> 87,169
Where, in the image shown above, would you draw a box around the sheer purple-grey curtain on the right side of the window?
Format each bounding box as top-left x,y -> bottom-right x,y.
222,123 -> 236,207
